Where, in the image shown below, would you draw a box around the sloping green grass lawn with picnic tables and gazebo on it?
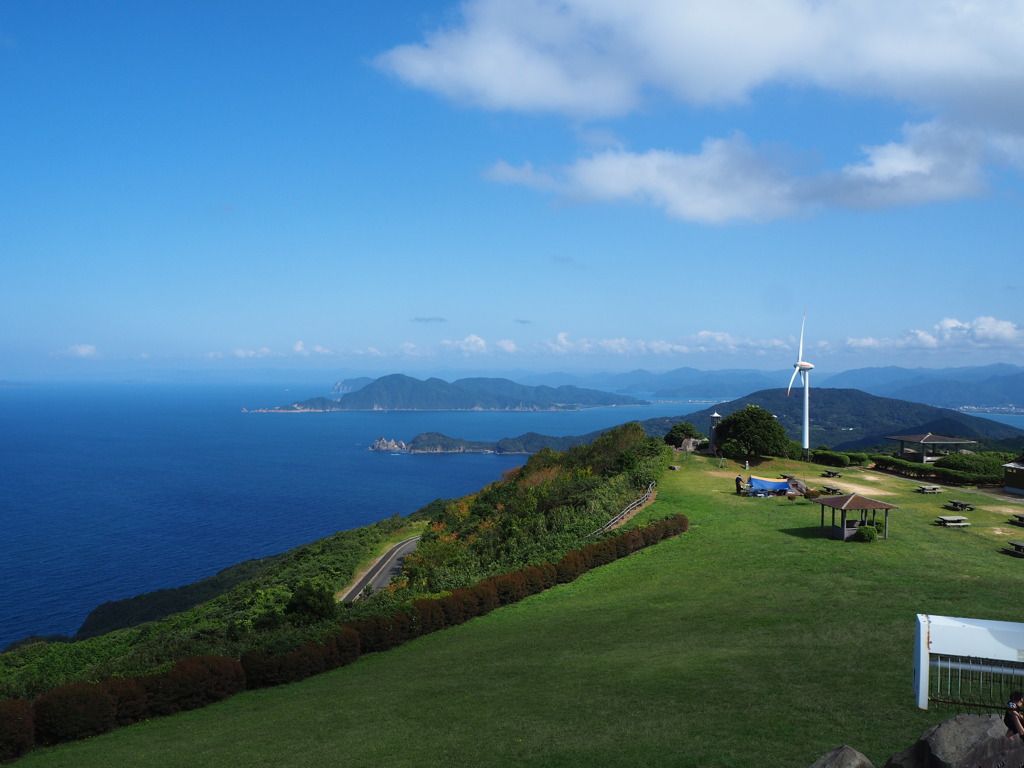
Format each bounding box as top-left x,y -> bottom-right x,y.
18,457 -> 1024,768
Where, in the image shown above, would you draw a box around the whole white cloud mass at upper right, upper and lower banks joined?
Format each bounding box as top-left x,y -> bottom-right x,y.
377,0 -> 1024,223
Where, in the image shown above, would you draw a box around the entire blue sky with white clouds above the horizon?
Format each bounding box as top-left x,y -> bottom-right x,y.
0,0 -> 1024,380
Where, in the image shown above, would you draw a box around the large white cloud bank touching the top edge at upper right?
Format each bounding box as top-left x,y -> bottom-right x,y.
377,0 -> 1024,121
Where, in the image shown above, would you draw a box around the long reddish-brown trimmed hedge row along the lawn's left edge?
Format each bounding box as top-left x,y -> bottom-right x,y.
0,515 -> 689,761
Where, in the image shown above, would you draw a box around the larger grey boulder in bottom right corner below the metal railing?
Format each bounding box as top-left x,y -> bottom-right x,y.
885,715 -> 1024,768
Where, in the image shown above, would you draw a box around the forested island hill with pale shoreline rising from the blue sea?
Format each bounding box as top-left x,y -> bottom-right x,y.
269,374 -> 646,412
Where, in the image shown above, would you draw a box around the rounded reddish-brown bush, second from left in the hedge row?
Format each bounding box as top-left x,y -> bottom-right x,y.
33,683 -> 116,744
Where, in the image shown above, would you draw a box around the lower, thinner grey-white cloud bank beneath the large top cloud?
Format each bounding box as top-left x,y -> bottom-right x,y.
486,123 -> 999,223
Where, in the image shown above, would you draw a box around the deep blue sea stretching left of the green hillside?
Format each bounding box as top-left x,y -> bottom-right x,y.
0,383 -> 705,649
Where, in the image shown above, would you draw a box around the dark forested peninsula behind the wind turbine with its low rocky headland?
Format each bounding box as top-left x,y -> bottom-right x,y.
409,389 -> 1024,453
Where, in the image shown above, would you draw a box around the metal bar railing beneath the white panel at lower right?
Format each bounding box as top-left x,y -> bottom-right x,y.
928,653 -> 1024,711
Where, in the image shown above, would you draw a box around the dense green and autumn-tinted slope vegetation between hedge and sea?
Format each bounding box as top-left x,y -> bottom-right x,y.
0,422 -> 672,699
